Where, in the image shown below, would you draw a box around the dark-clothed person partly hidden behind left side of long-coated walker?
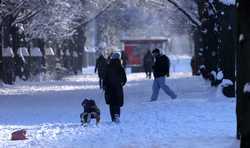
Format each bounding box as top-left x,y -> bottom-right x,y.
95,54 -> 107,89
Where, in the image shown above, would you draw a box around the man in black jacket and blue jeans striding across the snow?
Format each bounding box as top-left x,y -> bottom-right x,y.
151,48 -> 177,101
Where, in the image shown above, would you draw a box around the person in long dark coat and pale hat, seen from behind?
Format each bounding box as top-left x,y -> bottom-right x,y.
103,53 -> 127,122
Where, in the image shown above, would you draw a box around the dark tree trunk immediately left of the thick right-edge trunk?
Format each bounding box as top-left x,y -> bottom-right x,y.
216,3 -> 236,97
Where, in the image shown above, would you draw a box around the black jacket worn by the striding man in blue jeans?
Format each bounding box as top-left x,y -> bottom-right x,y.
153,55 -> 170,78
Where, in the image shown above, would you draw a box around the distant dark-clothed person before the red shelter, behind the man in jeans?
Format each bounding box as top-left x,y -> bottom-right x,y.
143,50 -> 154,79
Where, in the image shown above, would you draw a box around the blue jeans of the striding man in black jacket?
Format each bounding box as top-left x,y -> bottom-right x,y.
151,76 -> 177,101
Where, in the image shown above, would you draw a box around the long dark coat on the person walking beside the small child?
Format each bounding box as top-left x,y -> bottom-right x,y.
103,59 -> 127,107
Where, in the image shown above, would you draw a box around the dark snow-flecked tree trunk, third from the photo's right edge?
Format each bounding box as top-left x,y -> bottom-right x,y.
198,1 -> 220,86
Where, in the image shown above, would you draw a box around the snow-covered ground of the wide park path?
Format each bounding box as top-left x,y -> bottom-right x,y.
0,57 -> 239,148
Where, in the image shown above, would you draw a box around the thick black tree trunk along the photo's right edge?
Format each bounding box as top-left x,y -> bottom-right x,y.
236,0 -> 250,148
